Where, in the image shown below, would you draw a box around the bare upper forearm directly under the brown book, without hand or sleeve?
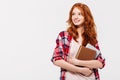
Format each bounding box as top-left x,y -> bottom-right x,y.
78,60 -> 103,69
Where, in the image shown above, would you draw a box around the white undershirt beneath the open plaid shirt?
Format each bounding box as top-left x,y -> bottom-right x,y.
65,39 -> 95,80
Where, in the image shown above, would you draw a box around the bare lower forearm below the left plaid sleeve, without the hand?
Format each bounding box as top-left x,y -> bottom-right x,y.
53,60 -> 81,73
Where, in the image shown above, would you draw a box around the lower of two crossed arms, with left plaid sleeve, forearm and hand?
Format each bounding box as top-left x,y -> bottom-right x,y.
51,32 -> 92,76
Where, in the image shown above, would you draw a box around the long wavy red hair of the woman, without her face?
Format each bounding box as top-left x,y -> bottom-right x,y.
67,3 -> 97,46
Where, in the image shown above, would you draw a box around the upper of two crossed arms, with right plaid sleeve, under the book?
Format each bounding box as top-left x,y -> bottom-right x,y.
69,43 -> 105,69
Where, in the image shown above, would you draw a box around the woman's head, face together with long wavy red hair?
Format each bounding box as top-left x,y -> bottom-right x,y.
67,3 -> 97,46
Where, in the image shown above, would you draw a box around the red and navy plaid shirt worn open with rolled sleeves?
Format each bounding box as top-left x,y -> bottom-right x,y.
51,31 -> 105,80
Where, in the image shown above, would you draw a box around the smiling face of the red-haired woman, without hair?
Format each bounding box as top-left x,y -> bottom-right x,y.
72,7 -> 84,26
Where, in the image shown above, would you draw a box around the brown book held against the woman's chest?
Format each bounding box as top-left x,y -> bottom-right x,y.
75,46 -> 96,60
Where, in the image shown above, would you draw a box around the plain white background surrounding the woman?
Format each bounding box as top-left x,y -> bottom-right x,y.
0,0 -> 120,80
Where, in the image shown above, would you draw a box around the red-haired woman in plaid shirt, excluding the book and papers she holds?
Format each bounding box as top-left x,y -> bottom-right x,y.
51,3 -> 105,80
